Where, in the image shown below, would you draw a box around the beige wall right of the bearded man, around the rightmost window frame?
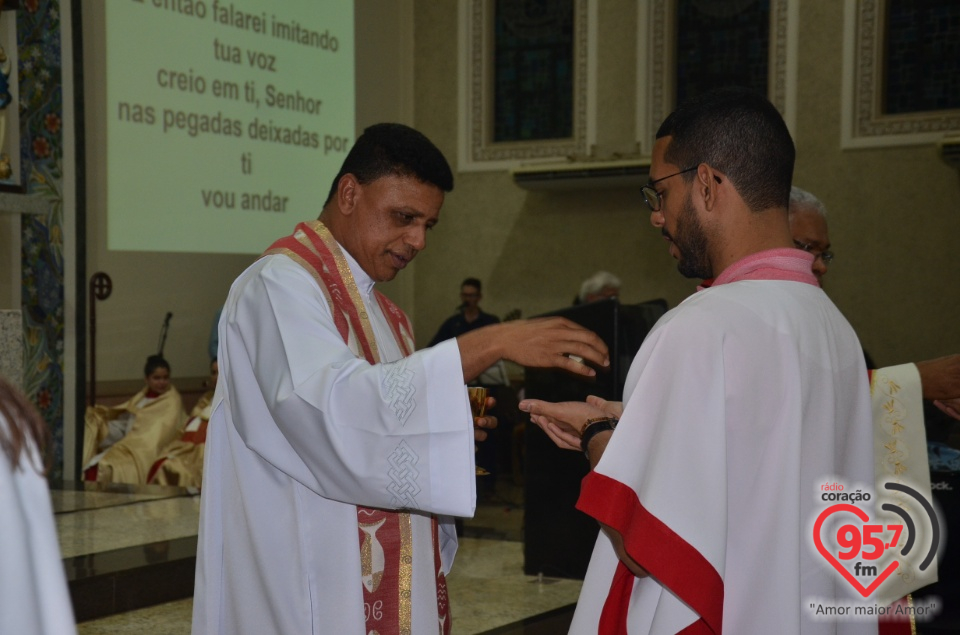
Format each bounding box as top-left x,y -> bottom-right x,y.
794,2 -> 960,365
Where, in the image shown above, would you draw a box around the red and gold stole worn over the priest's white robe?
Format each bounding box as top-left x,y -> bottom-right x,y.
264,221 -> 450,635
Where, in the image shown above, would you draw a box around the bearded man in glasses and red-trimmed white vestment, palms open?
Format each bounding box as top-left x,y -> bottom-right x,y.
520,89 -> 877,635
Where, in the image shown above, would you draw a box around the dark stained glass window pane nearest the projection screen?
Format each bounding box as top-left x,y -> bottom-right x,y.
493,0 -> 574,142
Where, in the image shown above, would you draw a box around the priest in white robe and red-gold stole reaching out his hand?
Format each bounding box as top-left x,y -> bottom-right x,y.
193,124 -> 608,635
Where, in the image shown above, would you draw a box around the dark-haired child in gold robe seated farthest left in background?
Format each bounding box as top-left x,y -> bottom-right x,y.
83,355 -> 186,485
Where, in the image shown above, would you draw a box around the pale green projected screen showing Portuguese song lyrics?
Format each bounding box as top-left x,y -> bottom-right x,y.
107,0 -> 354,250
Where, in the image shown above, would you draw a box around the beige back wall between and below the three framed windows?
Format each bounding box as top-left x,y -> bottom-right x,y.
413,0 -> 960,365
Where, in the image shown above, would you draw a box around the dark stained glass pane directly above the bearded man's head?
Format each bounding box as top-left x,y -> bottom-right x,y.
676,0 -> 770,103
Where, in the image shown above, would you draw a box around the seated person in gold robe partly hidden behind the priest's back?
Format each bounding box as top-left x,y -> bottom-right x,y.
147,359 -> 219,489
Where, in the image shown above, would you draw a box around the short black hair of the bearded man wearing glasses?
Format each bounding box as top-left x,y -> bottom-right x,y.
657,88 -> 796,212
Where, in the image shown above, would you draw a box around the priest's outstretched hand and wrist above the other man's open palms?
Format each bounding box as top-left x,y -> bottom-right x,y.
457,317 -> 610,381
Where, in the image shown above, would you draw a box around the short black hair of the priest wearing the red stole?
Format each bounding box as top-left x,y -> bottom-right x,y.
324,123 -> 453,205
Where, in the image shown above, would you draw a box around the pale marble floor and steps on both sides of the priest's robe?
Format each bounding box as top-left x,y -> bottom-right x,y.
52,485 -> 581,635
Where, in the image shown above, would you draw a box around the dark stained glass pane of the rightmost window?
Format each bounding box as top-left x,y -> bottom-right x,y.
883,0 -> 960,115
